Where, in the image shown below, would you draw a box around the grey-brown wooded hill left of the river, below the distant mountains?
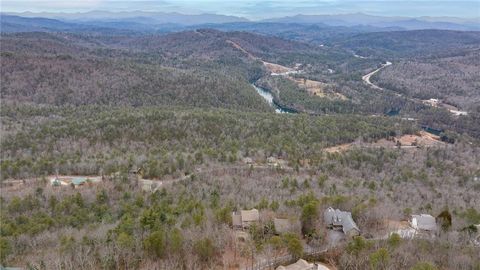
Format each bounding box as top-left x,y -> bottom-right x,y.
1,33 -> 278,111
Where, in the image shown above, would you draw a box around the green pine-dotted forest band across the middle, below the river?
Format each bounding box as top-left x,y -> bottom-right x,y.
1,105 -> 416,179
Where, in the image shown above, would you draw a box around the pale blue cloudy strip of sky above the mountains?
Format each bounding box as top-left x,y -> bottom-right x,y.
1,0 -> 480,19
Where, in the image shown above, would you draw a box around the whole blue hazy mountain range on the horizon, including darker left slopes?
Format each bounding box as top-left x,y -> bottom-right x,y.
0,11 -> 480,33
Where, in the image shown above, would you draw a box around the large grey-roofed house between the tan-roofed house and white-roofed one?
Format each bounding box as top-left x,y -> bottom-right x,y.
323,207 -> 360,237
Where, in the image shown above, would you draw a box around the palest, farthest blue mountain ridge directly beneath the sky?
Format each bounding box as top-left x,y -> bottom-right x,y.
0,10 -> 480,31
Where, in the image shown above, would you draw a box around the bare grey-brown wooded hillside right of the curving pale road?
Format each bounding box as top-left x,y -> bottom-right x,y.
376,49 -> 480,112
